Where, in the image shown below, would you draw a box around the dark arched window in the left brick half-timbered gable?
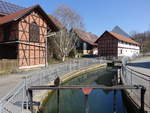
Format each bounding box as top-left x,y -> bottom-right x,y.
29,22 -> 40,42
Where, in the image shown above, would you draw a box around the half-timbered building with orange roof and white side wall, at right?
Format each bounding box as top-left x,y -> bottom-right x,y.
96,31 -> 140,58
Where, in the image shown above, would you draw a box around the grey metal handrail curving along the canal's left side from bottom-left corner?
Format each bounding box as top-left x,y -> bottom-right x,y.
0,58 -> 103,113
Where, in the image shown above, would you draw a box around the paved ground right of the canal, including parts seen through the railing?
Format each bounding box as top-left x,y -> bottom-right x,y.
126,56 -> 150,113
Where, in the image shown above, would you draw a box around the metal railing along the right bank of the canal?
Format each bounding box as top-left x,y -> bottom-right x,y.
121,66 -> 150,109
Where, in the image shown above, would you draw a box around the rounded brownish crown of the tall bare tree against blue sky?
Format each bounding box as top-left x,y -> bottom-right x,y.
54,5 -> 84,30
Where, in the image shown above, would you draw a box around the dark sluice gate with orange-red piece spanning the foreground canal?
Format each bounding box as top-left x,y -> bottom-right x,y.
28,78 -> 146,113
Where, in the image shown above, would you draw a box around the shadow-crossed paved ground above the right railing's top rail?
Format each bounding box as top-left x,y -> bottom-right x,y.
128,56 -> 150,76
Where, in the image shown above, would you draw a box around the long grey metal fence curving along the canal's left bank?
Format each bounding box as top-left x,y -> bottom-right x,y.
0,58 -> 105,113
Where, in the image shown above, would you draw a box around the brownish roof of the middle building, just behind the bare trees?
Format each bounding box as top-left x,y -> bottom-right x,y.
73,29 -> 98,46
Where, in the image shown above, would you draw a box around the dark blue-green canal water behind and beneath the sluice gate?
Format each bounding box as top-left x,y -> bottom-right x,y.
42,69 -> 127,113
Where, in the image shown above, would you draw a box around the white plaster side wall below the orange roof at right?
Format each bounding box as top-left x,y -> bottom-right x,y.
118,41 -> 140,57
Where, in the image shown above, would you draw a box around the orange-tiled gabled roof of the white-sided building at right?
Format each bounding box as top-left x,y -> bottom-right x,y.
96,31 -> 140,45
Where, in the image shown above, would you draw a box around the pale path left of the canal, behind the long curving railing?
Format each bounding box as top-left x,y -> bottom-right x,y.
0,58 -> 102,99
